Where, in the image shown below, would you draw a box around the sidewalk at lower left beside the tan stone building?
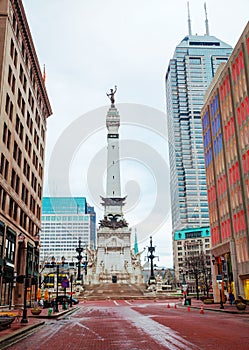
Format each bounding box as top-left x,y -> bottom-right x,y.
0,307 -> 75,348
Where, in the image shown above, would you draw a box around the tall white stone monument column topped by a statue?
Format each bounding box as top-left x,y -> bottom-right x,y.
92,87 -> 143,284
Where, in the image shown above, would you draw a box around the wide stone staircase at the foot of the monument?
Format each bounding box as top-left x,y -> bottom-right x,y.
81,283 -> 145,300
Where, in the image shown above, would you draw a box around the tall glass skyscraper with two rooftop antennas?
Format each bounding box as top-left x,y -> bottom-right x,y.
166,5 -> 232,275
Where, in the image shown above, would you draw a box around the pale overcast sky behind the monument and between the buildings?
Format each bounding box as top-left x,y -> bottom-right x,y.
23,0 -> 249,266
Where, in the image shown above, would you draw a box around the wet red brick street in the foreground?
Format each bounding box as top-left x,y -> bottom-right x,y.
2,300 -> 249,350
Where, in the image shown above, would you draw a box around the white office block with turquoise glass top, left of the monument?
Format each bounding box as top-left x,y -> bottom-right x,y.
40,197 -> 96,263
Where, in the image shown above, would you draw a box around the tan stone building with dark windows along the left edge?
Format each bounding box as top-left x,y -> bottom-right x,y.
0,0 -> 52,305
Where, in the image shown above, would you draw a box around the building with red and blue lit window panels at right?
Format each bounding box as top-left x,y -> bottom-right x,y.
201,23 -> 249,300
